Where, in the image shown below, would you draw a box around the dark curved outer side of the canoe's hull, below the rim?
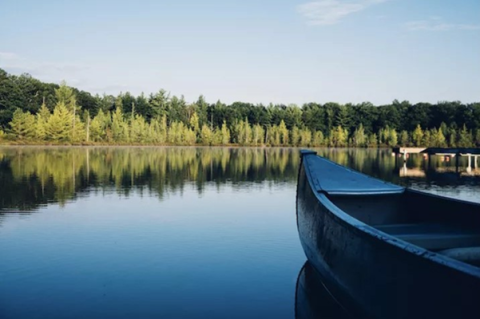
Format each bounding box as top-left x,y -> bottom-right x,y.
297,156 -> 480,318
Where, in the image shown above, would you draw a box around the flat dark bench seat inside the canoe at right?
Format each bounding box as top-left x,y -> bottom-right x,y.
375,223 -> 480,251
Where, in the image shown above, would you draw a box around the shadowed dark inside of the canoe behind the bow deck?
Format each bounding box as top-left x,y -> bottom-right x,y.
328,190 -> 480,258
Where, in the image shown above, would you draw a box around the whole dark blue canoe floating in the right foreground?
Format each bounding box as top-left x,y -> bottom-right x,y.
297,151 -> 480,318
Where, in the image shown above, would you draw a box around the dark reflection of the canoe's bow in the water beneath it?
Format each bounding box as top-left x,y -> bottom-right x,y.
295,261 -> 354,319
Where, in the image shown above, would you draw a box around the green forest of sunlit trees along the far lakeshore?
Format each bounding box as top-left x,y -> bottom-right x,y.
0,69 -> 480,147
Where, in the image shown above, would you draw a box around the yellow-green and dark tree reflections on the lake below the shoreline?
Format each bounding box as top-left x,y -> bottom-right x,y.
0,147 -> 479,212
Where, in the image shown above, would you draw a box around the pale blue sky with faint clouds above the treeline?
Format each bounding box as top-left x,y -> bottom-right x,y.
0,0 -> 480,104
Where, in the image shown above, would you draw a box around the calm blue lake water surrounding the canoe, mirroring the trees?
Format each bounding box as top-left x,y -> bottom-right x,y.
0,147 -> 480,319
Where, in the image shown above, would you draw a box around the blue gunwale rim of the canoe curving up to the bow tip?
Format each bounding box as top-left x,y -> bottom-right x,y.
300,151 -> 480,278
